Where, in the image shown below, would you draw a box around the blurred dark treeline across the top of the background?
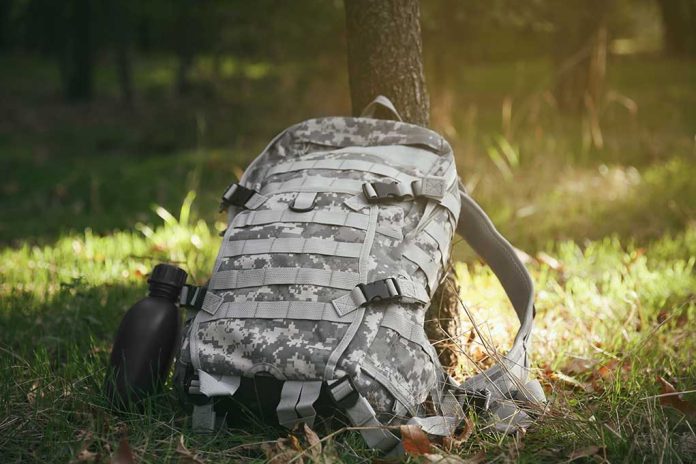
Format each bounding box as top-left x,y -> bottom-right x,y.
0,0 -> 684,112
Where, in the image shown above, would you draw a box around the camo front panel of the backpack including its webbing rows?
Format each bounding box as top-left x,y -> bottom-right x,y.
184,118 -> 456,416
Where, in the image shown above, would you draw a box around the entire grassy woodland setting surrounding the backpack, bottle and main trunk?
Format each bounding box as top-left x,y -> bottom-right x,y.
0,0 -> 696,462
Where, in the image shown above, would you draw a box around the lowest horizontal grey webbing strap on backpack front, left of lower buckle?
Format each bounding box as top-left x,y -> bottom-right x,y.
209,301 -> 353,323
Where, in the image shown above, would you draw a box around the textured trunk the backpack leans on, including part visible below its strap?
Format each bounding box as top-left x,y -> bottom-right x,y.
344,0 -> 459,370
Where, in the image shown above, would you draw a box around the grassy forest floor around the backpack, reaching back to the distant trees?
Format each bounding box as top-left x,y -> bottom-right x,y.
0,57 -> 696,463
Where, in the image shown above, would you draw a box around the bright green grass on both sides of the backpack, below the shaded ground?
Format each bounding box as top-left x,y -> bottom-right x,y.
0,189 -> 696,462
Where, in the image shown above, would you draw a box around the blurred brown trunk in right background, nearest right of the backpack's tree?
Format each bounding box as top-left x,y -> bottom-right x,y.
554,0 -> 611,113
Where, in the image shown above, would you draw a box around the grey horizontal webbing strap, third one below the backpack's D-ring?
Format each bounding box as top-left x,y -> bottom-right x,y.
209,267 -> 360,290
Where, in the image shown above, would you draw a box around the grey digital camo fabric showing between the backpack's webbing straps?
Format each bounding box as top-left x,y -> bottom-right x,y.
182,112 -> 456,423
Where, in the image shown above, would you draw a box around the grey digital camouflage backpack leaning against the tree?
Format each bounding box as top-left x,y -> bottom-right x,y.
175,97 -> 543,455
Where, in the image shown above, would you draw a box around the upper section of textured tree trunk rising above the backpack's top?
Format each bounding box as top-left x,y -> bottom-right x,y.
344,0 -> 430,126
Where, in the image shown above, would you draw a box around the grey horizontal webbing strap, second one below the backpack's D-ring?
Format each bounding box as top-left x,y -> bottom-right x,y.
222,237 -> 362,258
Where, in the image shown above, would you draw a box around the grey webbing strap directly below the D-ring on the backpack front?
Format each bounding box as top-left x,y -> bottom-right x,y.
230,210 -> 404,240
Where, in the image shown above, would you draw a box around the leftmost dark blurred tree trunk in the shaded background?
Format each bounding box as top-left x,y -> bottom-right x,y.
64,0 -> 93,101
